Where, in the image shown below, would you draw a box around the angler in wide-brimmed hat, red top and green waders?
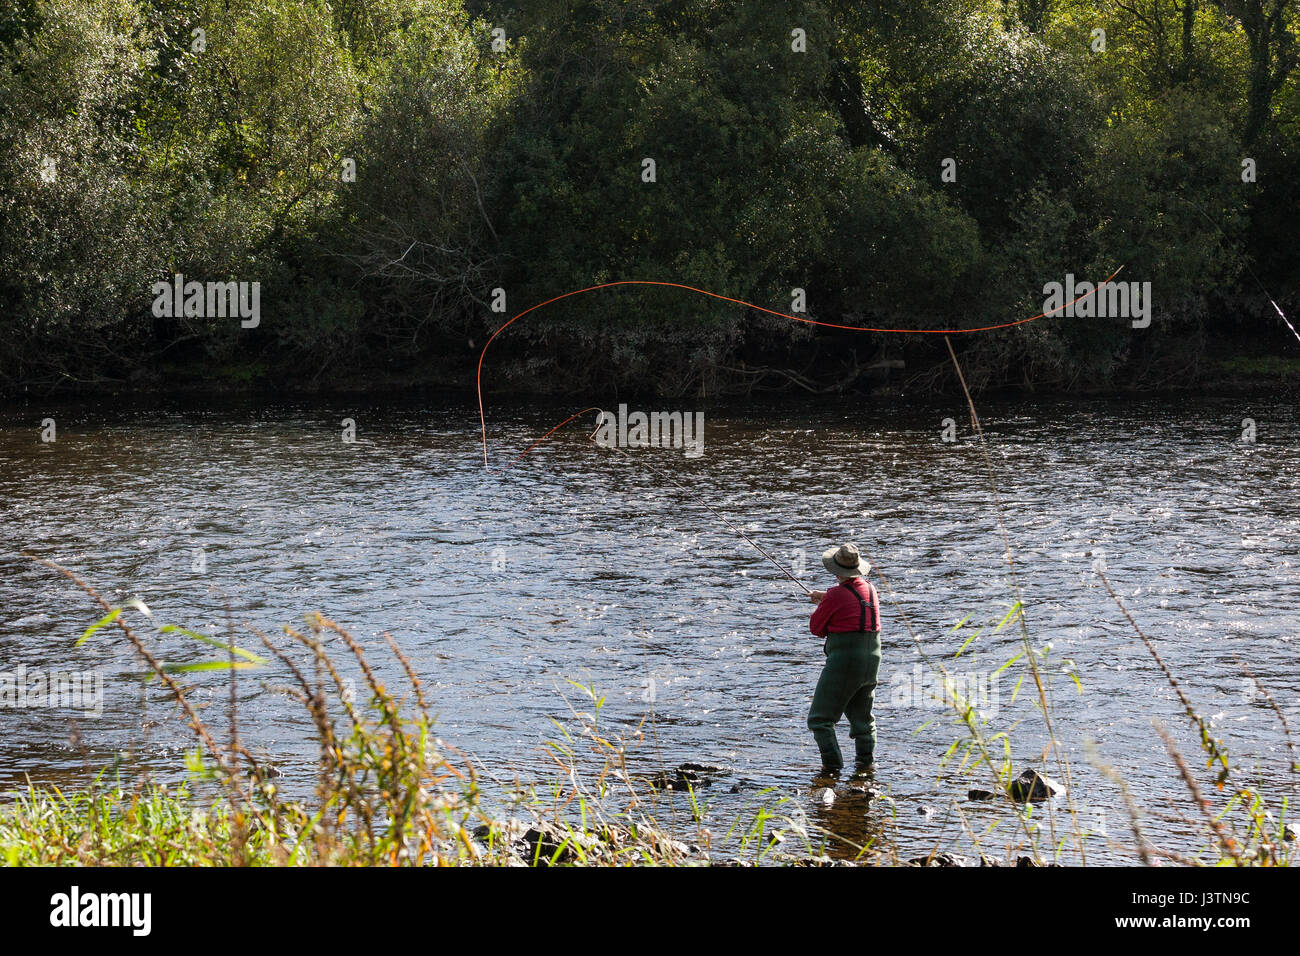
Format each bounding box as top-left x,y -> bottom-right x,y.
809,544 -> 880,777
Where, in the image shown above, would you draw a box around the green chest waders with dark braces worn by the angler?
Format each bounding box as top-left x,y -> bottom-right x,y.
809,584 -> 880,770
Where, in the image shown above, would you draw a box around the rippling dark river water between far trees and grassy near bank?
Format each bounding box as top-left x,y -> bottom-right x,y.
0,395 -> 1300,862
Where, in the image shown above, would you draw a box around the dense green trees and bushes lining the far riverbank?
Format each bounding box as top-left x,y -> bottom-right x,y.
0,0 -> 1300,394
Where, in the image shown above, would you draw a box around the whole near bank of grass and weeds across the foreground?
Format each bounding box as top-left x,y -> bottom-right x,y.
0,548 -> 1300,866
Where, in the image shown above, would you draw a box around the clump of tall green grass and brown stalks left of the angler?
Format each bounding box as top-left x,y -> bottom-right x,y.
0,555 -> 821,866
